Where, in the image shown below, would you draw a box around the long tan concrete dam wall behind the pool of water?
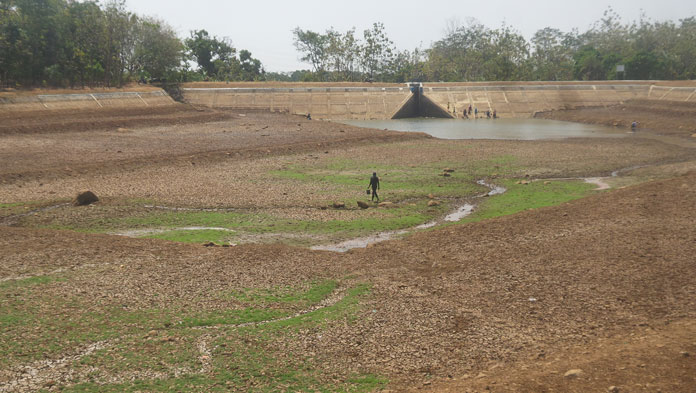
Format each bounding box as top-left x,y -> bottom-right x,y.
183,82 -> 696,120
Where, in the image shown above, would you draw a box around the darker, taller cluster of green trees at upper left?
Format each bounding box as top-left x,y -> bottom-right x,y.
0,0 -> 264,87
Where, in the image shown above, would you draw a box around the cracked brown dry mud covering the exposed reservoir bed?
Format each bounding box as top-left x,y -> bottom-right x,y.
0,102 -> 696,392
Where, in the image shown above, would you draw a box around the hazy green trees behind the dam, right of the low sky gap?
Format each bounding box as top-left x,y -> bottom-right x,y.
280,8 -> 696,82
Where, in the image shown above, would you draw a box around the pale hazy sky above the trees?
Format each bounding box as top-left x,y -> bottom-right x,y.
127,0 -> 696,71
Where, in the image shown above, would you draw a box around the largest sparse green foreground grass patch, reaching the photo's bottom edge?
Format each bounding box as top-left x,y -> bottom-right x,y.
62,280 -> 388,392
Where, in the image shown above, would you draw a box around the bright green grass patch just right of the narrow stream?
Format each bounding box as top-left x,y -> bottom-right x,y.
460,180 -> 595,222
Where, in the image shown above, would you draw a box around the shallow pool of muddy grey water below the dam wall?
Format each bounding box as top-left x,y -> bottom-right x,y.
341,118 -> 630,140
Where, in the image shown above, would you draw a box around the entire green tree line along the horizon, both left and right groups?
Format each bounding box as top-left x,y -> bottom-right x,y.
0,0 -> 696,87
